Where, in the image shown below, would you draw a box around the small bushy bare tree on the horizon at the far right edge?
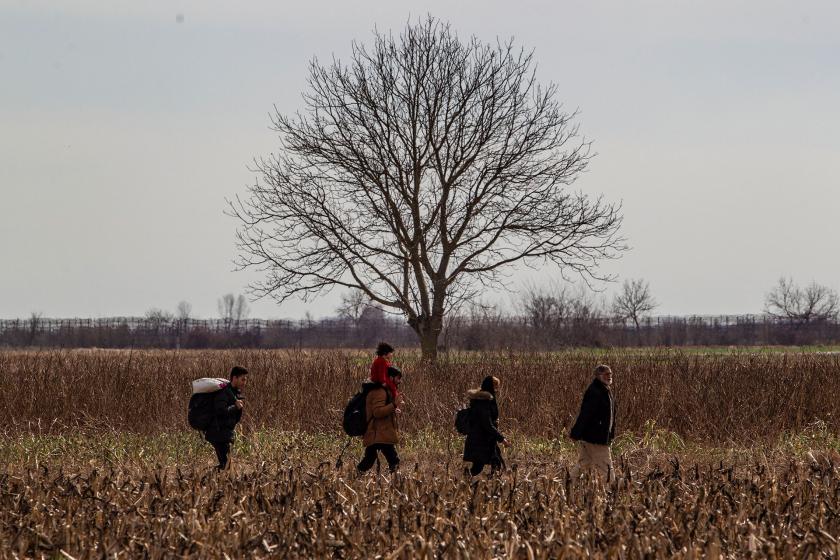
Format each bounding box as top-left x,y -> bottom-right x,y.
764,277 -> 840,324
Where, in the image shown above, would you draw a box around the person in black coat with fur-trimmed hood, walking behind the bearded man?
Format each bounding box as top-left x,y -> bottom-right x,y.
464,375 -> 510,476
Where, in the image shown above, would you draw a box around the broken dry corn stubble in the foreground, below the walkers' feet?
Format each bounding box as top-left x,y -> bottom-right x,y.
0,460 -> 840,559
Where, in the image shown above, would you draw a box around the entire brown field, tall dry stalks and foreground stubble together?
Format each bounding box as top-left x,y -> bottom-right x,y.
0,350 -> 840,559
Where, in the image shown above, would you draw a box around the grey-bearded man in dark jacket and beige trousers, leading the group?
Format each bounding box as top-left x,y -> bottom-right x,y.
569,365 -> 615,482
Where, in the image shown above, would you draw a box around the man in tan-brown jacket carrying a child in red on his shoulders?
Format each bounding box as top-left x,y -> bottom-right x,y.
358,366 -> 402,474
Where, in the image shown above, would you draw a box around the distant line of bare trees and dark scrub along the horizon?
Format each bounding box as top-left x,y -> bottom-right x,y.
6,279 -> 840,350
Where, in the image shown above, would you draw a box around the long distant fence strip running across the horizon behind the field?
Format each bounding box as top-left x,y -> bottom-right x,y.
0,315 -> 840,350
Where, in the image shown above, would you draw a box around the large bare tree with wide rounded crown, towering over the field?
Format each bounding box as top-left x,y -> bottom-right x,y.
230,18 -> 623,360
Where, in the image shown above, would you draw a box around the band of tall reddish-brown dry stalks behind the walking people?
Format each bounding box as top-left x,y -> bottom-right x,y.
0,350 -> 840,444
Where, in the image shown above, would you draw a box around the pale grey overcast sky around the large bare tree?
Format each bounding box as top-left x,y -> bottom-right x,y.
0,0 -> 840,318
